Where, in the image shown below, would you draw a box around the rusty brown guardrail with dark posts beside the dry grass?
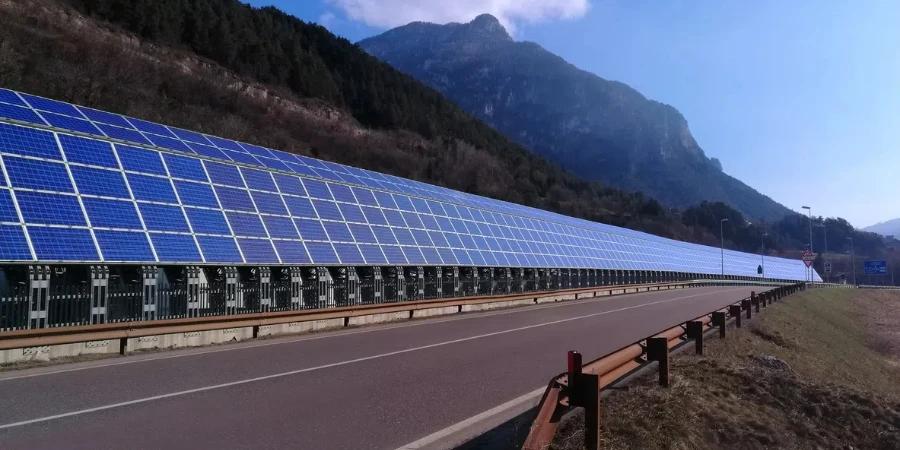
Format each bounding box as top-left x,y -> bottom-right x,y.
522,283 -> 807,450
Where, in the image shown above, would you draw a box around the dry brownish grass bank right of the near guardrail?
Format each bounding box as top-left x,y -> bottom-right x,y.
554,290 -> 900,450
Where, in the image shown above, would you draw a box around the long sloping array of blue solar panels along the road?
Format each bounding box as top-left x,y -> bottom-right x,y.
0,89 -> 824,280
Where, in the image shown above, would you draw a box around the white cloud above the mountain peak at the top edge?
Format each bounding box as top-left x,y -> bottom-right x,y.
328,0 -> 590,31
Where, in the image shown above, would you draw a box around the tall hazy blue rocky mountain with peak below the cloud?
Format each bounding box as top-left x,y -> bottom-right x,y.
358,15 -> 789,220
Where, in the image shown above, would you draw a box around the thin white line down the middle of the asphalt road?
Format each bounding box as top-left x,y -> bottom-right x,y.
0,289 -> 737,430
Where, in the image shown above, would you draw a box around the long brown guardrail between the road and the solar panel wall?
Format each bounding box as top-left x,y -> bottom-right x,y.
0,280 -> 740,356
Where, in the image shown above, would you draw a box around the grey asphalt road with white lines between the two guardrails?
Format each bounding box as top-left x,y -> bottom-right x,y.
0,287 -> 759,450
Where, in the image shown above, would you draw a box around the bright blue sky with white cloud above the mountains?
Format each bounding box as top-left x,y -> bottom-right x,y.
250,0 -> 900,227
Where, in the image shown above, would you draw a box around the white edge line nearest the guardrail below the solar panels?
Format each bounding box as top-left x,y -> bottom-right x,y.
0,288 -> 733,383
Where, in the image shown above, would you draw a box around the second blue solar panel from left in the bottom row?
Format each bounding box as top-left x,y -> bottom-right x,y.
28,227 -> 100,261
